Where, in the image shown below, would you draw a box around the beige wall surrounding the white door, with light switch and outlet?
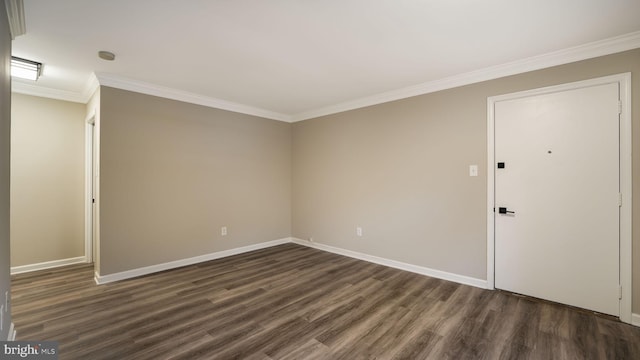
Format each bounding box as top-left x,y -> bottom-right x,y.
292,49 -> 640,313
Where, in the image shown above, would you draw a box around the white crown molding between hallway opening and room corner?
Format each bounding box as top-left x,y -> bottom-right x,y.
96,73 -> 291,122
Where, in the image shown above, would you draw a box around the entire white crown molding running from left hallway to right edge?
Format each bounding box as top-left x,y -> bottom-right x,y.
12,31 -> 640,122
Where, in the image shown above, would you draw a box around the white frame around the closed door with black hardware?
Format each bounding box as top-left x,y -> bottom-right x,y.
487,72 -> 632,324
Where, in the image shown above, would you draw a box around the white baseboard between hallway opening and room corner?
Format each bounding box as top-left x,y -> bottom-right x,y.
94,238 -> 291,285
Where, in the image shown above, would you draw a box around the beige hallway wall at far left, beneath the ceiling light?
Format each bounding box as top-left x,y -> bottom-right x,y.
11,94 -> 85,266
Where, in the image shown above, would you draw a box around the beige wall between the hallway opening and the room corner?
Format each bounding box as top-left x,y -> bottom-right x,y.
99,87 -> 291,275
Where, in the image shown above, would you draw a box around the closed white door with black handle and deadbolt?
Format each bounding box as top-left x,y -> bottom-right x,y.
494,83 -> 620,316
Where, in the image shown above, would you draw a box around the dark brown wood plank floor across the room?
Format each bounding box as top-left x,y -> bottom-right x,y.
12,244 -> 640,360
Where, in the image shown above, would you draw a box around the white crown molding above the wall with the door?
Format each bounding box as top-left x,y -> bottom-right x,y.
291,31 -> 640,122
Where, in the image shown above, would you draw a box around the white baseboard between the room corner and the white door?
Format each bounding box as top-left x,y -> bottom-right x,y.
291,238 -> 487,289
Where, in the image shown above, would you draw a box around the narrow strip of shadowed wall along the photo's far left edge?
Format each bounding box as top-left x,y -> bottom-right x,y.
0,6 -> 11,341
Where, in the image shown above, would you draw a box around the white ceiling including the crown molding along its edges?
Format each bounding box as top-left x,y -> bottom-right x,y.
8,0 -> 640,121
